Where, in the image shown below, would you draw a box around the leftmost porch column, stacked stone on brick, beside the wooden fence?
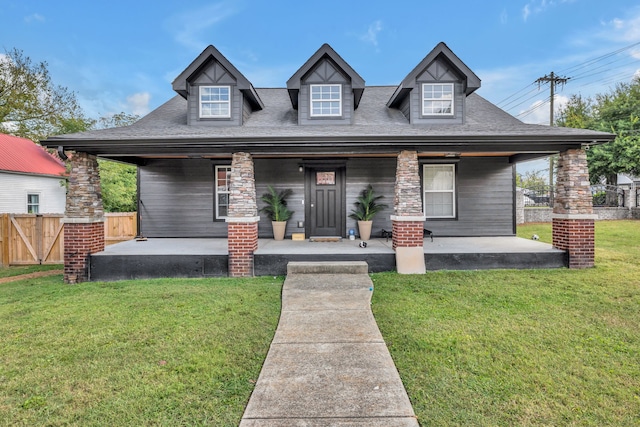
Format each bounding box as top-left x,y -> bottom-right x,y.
63,153 -> 104,284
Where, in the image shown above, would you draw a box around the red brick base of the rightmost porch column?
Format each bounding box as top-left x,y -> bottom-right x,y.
552,215 -> 595,268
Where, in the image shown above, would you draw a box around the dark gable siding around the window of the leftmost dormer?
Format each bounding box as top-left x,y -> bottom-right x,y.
187,61 -> 245,126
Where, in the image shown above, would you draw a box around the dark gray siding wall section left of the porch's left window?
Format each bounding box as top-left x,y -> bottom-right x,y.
139,159 -> 231,237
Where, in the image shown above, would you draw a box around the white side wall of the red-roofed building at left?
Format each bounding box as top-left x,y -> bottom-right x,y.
0,172 -> 67,214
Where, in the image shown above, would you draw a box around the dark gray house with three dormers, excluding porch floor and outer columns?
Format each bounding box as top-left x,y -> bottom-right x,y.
46,43 -> 613,284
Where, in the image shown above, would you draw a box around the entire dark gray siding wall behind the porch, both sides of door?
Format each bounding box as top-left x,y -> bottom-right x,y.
139,158 -> 514,238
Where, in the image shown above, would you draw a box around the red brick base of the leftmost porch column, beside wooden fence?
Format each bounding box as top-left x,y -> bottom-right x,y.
64,219 -> 104,284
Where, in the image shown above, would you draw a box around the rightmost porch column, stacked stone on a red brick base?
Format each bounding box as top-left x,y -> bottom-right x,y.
552,149 -> 597,268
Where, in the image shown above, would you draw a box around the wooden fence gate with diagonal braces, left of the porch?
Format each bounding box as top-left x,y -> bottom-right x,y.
2,214 -> 64,265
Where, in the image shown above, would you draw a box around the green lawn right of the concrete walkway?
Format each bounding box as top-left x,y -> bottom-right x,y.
373,221 -> 640,426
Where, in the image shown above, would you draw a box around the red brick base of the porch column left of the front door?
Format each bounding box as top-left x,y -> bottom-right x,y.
227,218 -> 258,277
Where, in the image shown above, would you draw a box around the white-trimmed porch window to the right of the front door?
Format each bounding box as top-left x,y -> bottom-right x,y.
422,164 -> 456,218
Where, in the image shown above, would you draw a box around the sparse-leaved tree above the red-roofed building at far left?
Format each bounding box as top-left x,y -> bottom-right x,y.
0,49 -> 85,142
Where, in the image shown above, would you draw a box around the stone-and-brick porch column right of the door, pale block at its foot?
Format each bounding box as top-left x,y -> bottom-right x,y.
391,151 -> 425,273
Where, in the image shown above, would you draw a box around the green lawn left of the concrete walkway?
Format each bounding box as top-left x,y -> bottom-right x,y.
0,276 -> 282,426
